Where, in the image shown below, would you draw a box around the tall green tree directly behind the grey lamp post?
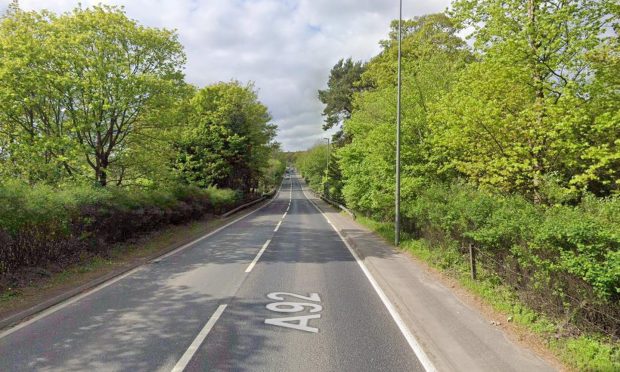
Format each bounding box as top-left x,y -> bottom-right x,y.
338,14 -> 470,217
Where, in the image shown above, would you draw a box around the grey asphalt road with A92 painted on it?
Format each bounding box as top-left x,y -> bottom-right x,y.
0,177 -> 424,371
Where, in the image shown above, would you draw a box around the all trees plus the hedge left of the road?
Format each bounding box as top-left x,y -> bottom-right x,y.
0,2 -> 285,293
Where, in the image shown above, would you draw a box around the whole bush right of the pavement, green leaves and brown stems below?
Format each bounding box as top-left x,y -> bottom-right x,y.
390,183 -> 620,337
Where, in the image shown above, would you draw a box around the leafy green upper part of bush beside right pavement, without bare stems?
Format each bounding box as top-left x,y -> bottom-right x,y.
403,184 -> 620,304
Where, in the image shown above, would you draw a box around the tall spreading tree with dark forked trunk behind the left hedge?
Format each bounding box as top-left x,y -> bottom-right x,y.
56,7 -> 185,186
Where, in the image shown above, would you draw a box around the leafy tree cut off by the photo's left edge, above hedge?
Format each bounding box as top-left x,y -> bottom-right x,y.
0,2 -> 77,183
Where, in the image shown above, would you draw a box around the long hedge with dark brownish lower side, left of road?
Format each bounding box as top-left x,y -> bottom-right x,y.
0,181 -> 242,279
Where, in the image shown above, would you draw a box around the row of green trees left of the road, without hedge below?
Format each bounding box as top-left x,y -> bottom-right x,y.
0,3 -> 278,192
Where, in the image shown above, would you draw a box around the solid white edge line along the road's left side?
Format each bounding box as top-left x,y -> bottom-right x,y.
0,180 -> 282,339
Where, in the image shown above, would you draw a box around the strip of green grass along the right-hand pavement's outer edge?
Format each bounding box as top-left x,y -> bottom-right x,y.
357,216 -> 620,372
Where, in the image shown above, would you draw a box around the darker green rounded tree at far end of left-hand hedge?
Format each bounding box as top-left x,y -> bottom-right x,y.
176,81 -> 277,192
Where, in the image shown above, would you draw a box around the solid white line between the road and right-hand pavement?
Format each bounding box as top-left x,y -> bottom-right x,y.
303,187 -> 437,372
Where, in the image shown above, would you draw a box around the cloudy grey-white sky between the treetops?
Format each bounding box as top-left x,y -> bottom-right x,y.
0,0 -> 450,150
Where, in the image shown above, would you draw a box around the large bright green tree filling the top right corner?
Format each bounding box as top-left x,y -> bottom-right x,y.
433,0 -> 620,201
